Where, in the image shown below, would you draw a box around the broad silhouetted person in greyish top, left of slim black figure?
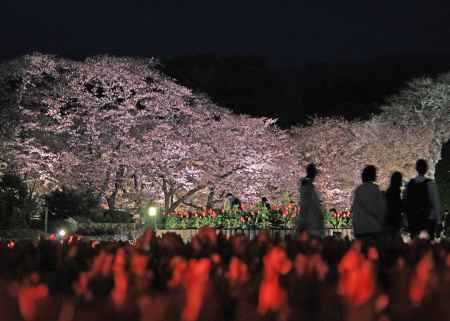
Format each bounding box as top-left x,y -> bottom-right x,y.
352,165 -> 386,238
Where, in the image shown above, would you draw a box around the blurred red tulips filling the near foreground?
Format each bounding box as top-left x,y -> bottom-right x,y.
0,228 -> 450,321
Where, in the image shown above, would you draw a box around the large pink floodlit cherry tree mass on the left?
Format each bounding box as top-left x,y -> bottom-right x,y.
3,54 -> 295,210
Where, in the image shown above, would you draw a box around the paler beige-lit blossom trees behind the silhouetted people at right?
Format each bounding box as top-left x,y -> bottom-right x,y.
292,73 -> 450,209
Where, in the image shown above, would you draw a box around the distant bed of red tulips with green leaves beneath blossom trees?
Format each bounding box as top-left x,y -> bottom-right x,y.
161,203 -> 351,230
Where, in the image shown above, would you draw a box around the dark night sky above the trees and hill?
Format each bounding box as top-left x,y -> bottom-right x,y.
0,0 -> 450,63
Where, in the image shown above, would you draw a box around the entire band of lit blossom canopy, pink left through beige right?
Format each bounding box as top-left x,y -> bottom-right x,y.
0,54 -> 450,210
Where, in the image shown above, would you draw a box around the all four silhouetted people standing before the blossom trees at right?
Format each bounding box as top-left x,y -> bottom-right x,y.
297,159 -> 443,239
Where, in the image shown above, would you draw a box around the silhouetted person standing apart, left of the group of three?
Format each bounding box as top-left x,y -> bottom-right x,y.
297,163 -> 325,237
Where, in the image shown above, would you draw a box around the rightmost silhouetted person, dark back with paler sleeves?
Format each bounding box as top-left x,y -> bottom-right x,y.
404,159 -> 442,239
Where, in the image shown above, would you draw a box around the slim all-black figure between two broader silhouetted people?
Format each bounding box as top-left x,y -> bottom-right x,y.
385,172 -> 403,235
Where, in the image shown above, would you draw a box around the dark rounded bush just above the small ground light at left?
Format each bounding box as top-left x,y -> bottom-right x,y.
45,186 -> 98,218
